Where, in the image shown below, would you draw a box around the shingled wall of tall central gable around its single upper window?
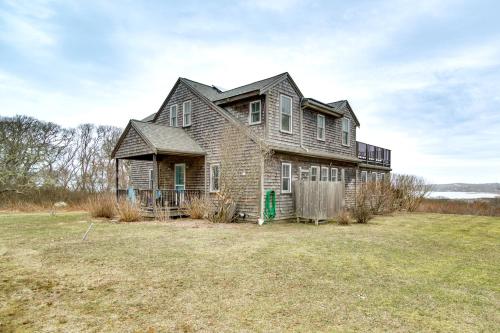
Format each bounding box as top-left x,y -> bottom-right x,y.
266,80 -> 300,146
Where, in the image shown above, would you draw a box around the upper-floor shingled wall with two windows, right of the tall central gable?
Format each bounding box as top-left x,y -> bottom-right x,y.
302,109 -> 356,156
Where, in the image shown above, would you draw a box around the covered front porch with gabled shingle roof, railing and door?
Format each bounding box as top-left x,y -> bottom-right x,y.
112,120 -> 206,217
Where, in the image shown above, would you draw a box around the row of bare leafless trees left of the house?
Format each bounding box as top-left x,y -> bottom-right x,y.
0,115 -> 126,198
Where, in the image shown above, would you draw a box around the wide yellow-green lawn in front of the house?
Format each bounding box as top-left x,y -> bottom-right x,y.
0,213 -> 500,332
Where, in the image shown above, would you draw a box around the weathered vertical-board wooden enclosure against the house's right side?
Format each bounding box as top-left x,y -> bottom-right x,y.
293,180 -> 344,224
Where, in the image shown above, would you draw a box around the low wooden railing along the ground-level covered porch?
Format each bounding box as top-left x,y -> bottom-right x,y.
118,189 -> 203,208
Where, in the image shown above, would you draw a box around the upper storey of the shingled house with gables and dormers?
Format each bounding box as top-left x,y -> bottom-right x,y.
148,73 -> 390,166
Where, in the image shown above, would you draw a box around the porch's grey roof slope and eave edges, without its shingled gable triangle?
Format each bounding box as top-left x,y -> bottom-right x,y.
111,119 -> 205,158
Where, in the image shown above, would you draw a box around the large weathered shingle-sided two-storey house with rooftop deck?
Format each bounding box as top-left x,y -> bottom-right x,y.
112,73 -> 391,221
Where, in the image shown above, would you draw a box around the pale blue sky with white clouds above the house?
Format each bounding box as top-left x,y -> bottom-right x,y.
0,0 -> 500,183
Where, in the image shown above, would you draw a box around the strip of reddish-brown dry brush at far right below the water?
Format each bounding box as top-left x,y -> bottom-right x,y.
417,198 -> 500,216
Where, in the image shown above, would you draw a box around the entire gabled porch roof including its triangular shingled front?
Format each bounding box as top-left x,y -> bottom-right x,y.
111,119 -> 205,158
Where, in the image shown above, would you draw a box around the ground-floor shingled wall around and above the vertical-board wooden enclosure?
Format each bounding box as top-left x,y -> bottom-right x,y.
264,153 -> 357,219
